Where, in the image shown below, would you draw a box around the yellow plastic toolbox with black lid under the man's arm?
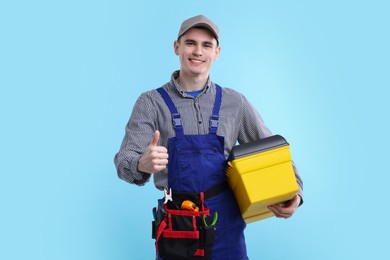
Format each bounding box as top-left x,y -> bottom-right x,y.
226,135 -> 298,223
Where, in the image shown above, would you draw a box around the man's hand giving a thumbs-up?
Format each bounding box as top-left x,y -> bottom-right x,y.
138,130 -> 168,174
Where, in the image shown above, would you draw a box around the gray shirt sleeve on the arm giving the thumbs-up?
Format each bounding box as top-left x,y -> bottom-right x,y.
114,93 -> 155,186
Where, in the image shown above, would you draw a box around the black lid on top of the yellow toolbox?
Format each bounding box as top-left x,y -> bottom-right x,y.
228,135 -> 288,161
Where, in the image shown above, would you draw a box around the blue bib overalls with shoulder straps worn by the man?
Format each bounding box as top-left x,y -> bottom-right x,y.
158,85 -> 248,260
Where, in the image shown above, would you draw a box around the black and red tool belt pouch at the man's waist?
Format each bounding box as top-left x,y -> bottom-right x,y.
152,192 -> 217,260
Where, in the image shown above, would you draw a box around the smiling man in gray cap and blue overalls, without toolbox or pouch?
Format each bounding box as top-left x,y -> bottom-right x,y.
115,15 -> 303,260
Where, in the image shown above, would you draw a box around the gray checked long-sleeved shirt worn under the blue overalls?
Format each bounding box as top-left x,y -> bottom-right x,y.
114,71 -> 303,197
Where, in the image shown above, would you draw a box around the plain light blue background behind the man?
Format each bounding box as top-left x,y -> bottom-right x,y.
0,0 -> 390,260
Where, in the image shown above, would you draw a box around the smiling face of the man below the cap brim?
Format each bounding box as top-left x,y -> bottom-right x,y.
174,28 -> 221,78
